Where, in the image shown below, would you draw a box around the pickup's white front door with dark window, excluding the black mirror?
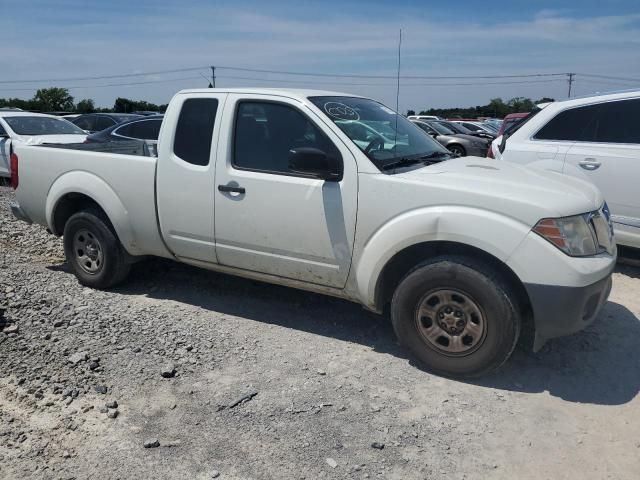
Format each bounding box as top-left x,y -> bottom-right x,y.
215,95 -> 358,287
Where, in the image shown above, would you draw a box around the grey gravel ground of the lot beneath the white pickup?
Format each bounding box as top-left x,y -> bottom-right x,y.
0,187 -> 640,480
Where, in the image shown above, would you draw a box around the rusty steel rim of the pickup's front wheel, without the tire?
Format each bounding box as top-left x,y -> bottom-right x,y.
416,288 -> 487,356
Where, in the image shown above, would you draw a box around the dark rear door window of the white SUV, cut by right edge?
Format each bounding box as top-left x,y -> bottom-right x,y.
593,99 -> 640,144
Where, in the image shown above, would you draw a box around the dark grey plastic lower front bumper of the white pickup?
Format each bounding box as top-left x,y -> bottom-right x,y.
524,271 -> 612,351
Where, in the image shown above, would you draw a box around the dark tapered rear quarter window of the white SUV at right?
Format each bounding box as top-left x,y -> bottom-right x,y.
533,105 -> 598,142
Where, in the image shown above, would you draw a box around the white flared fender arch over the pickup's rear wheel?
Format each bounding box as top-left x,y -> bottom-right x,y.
45,170 -> 138,255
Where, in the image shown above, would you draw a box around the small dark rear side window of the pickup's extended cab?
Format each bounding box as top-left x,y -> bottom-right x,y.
173,98 -> 218,166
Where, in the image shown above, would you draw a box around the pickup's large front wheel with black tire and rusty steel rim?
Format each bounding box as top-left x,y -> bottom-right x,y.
391,256 -> 521,378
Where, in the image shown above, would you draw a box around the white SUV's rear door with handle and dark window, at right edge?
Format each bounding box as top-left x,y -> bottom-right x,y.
565,98 -> 640,240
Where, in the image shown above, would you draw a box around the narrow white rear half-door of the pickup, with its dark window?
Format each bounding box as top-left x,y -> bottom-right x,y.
156,93 -> 226,263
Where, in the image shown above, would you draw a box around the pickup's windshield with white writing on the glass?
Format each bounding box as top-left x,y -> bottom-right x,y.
309,97 -> 448,170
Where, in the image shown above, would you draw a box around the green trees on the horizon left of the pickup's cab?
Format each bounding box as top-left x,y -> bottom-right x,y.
0,87 -> 167,113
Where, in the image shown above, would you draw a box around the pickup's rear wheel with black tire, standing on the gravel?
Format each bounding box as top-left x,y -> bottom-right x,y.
63,209 -> 131,289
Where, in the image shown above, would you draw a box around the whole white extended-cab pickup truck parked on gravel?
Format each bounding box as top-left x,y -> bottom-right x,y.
7,89 -> 616,377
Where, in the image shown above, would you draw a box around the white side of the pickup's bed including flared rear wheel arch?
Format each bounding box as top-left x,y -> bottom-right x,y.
15,142 -> 170,257
